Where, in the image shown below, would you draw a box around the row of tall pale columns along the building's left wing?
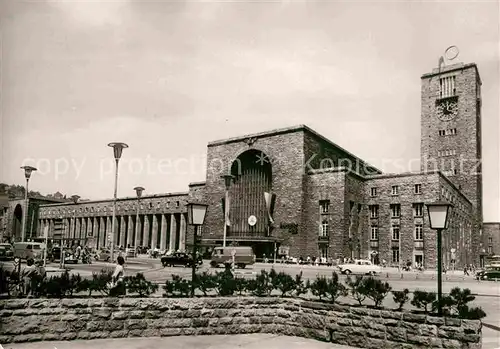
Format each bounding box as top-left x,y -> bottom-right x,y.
37,213 -> 187,252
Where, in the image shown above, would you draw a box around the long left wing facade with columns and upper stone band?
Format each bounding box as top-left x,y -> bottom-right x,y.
36,192 -> 193,251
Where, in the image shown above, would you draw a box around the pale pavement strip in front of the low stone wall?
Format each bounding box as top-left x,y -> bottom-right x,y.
3,334 -> 355,349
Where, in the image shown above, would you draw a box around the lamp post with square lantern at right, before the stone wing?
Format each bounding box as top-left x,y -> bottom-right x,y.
426,201 -> 453,316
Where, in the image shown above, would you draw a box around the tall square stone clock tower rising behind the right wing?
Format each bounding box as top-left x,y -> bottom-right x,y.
420,63 -> 483,265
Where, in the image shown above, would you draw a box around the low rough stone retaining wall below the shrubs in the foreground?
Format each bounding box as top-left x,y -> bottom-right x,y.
0,297 -> 481,349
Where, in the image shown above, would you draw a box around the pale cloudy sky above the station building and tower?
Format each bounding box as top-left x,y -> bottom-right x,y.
0,0 -> 500,221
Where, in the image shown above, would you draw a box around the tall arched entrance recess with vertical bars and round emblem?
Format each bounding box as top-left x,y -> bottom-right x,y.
228,149 -> 273,257
